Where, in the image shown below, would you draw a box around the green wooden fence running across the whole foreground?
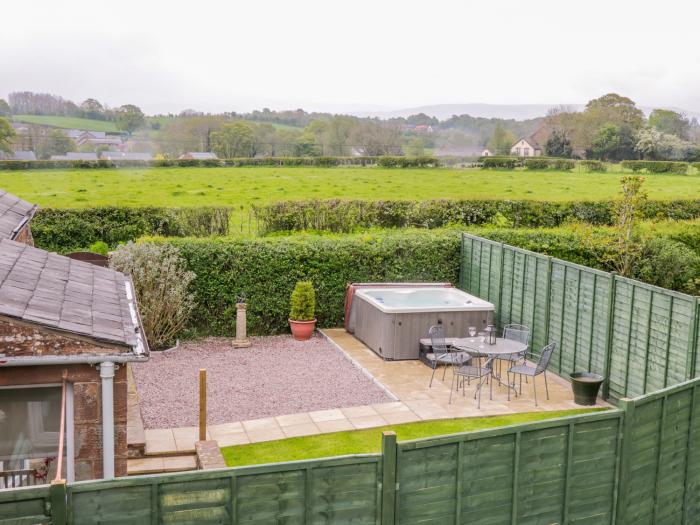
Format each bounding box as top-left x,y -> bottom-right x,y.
0,379 -> 700,525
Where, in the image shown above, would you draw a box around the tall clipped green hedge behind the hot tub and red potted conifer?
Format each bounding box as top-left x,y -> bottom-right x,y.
154,230 -> 460,335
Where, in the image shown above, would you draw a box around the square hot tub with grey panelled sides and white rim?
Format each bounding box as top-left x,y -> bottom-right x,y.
350,285 -> 494,359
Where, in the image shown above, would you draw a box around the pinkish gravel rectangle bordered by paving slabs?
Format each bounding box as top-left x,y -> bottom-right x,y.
133,336 -> 391,428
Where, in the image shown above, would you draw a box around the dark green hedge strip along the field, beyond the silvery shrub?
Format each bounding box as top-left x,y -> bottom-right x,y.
32,207 -> 230,253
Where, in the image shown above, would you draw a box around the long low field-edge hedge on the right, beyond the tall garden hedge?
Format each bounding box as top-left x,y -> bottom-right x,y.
253,199 -> 700,234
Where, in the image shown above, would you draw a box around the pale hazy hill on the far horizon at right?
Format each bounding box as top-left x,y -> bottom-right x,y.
353,104 -> 700,120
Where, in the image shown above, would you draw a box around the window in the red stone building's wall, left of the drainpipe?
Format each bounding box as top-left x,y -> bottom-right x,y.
0,385 -> 72,489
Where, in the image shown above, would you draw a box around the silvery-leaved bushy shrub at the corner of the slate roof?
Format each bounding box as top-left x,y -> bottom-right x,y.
109,242 -> 195,349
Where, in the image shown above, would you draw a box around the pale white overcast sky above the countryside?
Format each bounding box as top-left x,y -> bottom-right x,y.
0,0 -> 700,113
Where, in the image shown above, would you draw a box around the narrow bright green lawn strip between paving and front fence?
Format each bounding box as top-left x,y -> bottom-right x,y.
221,408 -> 605,467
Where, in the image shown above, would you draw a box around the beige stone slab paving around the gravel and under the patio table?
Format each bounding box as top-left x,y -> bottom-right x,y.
130,329 -> 609,470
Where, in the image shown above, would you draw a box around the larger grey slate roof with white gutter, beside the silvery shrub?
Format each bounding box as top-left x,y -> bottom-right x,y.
0,239 -> 148,355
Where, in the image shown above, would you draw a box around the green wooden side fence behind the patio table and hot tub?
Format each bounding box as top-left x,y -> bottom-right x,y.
460,234 -> 700,399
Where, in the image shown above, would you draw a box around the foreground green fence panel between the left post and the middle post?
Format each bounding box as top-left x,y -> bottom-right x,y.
68,455 -> 381,525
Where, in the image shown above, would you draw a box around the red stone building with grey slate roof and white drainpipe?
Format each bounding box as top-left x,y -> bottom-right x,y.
0,187 -> 149,488
